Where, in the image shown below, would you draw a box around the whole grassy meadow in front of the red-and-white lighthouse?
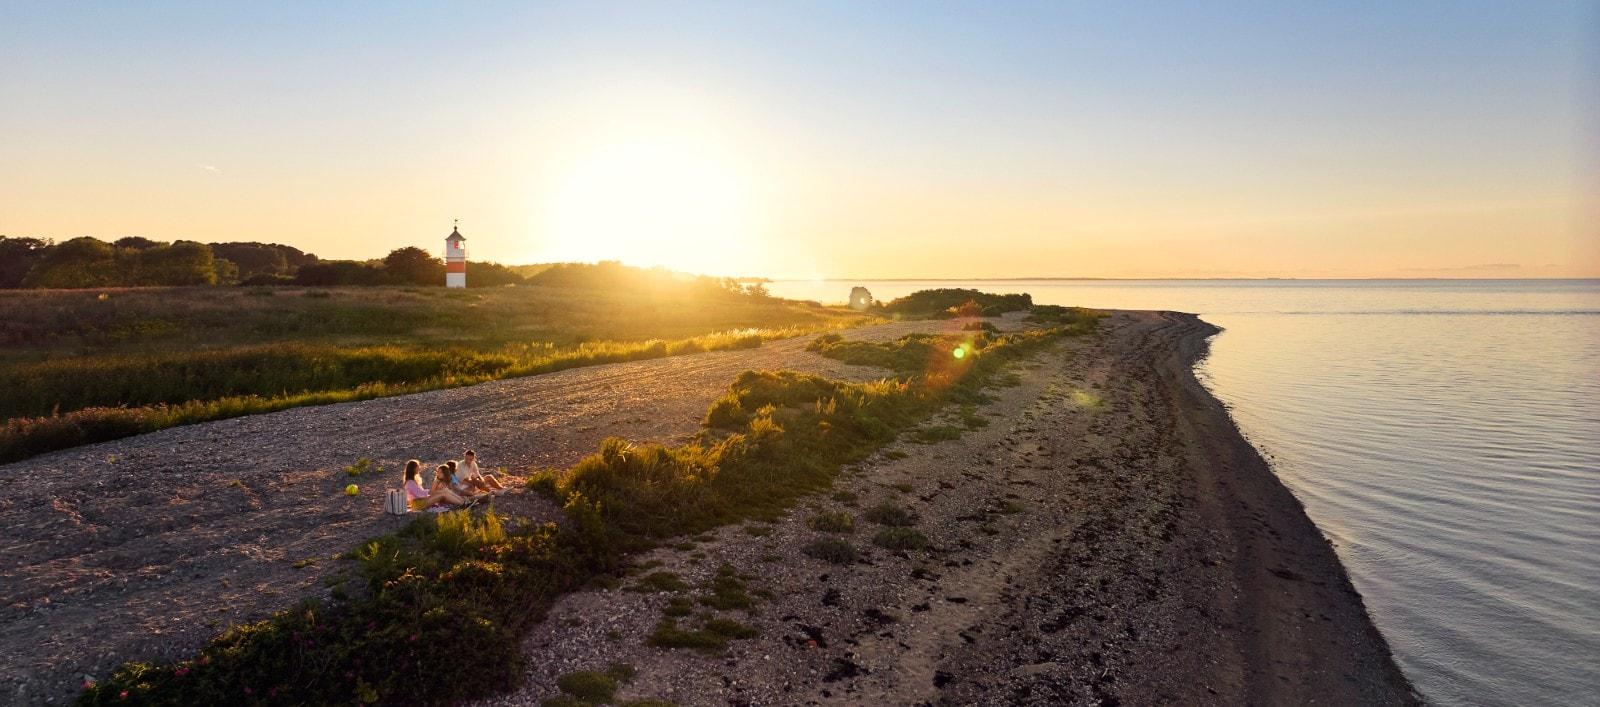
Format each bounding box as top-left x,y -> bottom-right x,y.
0,288 -> 862,461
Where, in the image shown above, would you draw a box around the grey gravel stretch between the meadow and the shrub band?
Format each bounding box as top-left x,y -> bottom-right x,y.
0,322 -> 972,704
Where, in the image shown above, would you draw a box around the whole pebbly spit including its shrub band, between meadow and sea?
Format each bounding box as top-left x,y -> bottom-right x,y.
0,300 -> 1411,704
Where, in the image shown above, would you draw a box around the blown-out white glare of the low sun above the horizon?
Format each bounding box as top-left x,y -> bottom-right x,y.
546,136 -> 758,275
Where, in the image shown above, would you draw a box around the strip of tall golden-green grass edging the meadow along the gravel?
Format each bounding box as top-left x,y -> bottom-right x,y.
0,330 -> 780,462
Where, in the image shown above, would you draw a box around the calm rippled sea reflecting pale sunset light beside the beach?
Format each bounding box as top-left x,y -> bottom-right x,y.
771,280 -> 1600,705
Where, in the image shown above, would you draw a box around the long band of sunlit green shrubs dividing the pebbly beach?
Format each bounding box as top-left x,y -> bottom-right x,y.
78,321 -> 1088,705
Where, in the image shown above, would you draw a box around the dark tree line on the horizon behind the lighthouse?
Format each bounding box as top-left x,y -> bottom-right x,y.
0,235 -> 526,290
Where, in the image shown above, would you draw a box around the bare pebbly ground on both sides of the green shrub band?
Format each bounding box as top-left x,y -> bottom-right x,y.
0,312 -> 1414,704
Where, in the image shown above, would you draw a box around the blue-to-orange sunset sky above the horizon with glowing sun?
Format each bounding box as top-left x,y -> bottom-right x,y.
0,0 -> 1600,277
